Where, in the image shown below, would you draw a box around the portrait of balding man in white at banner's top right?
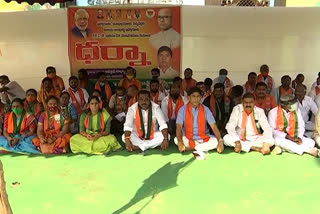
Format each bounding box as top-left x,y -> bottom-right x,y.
149,8 -> 180,50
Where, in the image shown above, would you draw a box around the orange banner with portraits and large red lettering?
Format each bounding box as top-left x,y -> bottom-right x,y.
68,7 -> 181,84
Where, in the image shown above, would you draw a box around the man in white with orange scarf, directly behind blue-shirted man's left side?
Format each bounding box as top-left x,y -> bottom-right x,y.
161,84 -> 188,135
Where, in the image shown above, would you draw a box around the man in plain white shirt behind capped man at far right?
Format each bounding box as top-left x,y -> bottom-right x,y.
295,84 -> 318,138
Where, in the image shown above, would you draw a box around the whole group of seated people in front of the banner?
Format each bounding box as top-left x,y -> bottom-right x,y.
0,65 -> 320,160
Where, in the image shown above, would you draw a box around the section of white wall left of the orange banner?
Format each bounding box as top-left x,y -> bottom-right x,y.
0,9 -> 70,90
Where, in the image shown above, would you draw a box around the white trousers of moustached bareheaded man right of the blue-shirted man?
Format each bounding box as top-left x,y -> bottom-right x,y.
223,134 -> 274,152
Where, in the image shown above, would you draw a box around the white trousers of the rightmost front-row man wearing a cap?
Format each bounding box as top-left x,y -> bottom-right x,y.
274,137 -> 315,155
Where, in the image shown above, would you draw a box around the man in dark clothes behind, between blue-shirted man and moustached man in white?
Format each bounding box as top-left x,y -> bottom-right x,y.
203,83 -> 230,137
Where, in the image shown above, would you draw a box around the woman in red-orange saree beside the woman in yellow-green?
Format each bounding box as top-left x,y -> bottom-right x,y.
32,96 -> 71,154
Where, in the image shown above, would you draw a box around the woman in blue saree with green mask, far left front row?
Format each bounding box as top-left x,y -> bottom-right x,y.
0,98 -> 40,154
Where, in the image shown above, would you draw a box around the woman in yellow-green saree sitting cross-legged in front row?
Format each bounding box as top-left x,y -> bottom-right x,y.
70,96 -> 121,154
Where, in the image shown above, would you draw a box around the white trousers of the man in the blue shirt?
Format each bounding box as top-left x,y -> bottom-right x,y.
174,136 -> 218,152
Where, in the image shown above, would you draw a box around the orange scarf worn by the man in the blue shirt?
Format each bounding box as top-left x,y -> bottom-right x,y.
185,103 -> 210,149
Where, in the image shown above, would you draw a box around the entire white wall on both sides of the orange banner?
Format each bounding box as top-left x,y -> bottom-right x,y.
0,6 -> 320,89
